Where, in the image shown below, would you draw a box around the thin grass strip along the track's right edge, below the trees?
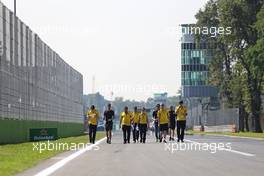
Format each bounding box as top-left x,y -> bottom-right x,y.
187,130 -> 264,139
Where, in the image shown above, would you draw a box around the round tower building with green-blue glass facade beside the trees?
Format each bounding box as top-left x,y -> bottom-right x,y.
181,24 -> 217,97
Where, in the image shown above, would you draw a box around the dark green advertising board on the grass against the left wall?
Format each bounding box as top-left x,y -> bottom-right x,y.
29,128 -> 58,141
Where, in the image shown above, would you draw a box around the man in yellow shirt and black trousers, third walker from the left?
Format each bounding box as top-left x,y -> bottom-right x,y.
119,106 -> 132,144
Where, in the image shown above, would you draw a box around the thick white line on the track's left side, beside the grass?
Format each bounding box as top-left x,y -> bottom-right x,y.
35,137 -> 106,176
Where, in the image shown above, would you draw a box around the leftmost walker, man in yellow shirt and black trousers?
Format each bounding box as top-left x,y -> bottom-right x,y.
87,105 -> 99,144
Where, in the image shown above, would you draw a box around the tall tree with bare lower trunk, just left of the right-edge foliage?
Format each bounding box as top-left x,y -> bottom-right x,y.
219,0 -> 263,132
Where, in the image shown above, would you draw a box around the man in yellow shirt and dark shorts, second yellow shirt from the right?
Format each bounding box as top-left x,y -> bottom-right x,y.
158,104 -> 169,143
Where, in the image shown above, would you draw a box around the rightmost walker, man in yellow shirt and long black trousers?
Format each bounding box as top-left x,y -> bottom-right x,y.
175,101 -> 187,142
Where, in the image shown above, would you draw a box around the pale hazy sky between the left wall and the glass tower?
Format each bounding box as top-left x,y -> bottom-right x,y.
2,0 -> 207,100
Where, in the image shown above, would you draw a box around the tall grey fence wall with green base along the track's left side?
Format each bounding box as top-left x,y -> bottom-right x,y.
0,2 -> 83,143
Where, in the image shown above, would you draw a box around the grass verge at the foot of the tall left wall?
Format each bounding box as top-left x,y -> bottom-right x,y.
0,132 -> 105,176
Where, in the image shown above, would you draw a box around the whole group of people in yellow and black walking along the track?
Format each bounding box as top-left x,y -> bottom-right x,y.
87,101 -> 187,144
